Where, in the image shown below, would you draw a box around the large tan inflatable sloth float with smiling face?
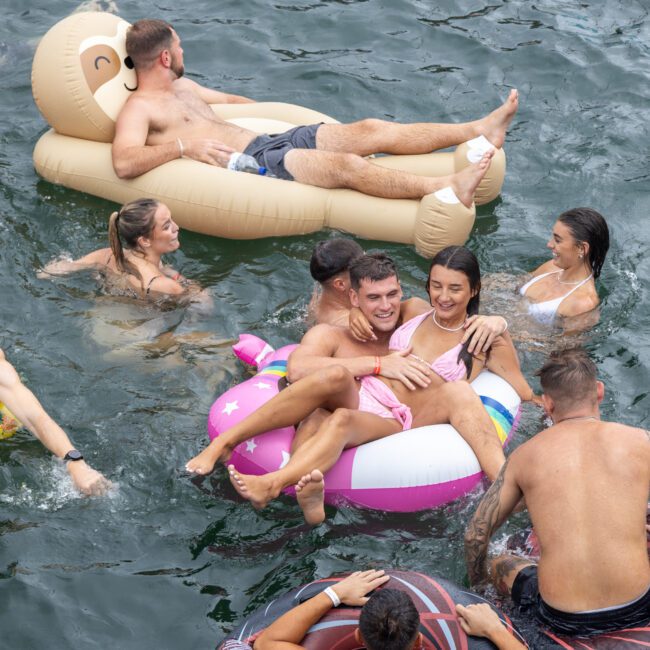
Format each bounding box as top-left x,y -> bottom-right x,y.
32,13 -> 505,256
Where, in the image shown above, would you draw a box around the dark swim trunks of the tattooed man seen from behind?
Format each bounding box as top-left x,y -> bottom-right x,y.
512,565 -> 650,636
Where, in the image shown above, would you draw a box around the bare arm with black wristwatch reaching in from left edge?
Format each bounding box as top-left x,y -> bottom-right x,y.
0,350 -> 111,494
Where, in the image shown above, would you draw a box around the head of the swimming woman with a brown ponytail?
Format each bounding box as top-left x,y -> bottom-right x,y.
108,199 -> 180,276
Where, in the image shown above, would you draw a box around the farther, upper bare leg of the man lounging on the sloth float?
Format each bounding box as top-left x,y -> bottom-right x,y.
316,90 -> 519,156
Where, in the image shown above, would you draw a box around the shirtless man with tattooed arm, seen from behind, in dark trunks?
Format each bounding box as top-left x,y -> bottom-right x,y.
465,349 -> 650,636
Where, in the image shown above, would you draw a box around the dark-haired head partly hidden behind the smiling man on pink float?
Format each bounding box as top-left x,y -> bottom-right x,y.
309,237 -> 363,296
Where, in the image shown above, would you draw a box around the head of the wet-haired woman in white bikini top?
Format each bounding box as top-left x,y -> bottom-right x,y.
548,208 -> 609,280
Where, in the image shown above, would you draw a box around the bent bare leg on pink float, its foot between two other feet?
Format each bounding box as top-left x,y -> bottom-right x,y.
228,408 -> 401,509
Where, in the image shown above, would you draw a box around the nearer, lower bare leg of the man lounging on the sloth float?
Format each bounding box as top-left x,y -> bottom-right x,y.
284,149 -> 494,207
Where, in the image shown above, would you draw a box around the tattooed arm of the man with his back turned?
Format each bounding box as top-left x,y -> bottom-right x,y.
465,452 -> 522,585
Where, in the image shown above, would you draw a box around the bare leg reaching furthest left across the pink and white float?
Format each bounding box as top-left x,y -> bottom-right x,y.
185,366 -> 359,474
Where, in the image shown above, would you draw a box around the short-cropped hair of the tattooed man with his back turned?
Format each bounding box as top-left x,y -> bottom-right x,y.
536,348 -> 596,406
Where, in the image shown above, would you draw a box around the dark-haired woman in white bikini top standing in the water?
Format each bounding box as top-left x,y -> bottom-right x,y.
519,208 -> 609,325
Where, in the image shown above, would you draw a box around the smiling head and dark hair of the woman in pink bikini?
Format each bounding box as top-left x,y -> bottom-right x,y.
426,246 -> 481,375
